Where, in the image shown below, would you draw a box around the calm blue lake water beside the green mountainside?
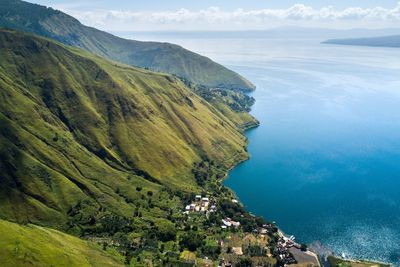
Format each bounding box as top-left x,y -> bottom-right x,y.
126,33 -> 400,266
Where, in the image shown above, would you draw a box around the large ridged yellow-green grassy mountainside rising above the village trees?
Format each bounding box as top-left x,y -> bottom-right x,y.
0,30 -> 247,228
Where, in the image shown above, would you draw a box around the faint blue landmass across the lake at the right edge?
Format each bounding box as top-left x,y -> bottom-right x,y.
323,35 -> 400,47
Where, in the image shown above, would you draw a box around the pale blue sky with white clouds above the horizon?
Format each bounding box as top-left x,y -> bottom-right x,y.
28,0 -> 400,31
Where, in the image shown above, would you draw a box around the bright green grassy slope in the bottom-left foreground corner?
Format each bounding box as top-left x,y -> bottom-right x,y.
0,220 -> 123,267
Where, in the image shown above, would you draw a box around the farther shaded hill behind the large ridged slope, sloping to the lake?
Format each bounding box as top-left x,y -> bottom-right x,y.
0,0 -> 254,91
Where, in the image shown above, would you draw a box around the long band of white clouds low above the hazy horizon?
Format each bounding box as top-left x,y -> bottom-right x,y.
60,2 -> 400,30
